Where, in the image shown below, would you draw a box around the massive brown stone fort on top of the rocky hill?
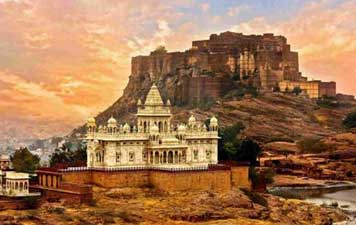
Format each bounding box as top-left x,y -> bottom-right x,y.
130,31 -> 336,104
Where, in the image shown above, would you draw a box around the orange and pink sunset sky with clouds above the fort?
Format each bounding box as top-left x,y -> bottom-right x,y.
0,0 -> 356,139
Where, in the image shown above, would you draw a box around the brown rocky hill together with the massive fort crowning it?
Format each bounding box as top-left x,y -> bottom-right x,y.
70,32 -> 356,142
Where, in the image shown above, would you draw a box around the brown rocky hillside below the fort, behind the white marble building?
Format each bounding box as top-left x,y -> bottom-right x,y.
72,74 -> 356,142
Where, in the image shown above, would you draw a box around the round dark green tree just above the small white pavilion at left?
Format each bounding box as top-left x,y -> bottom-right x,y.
10,148 -> 40,173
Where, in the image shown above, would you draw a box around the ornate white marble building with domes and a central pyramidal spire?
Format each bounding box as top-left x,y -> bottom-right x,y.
87,85 -> 219,168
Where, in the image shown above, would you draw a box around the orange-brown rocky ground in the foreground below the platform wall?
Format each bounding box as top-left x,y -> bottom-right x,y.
0,187 -> 346,225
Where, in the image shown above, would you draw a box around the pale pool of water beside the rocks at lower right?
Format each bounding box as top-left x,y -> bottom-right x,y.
269,184 -> 356,225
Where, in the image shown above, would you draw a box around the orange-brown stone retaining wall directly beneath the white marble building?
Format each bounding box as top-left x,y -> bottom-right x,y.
62,167 -> 250,192
